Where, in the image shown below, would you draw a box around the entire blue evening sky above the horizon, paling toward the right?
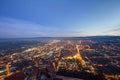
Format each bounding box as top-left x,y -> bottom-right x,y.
0,0 -> 120,38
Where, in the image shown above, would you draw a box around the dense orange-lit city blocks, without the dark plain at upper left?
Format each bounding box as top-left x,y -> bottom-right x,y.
0,40 -> 120,80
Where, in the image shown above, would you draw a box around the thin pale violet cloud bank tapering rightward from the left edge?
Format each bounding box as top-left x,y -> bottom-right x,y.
0,16 -> 85,37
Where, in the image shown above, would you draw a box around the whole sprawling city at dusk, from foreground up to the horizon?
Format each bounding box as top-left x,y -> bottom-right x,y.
0,36 -> 120,80
